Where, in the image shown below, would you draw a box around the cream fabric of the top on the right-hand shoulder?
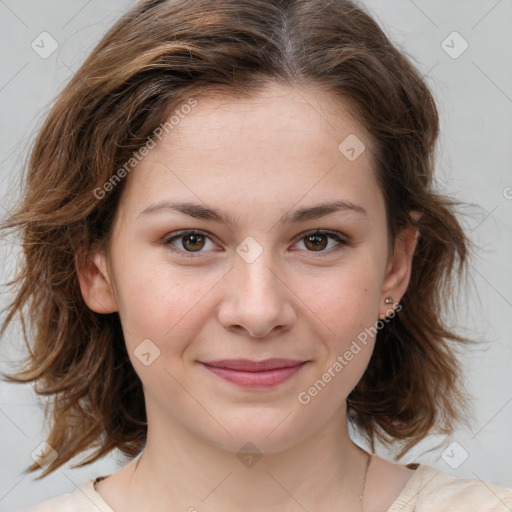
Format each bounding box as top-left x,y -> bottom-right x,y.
396,464 -> 512,512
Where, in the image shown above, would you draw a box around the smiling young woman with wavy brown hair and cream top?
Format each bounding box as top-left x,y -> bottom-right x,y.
3,0 -> 512,512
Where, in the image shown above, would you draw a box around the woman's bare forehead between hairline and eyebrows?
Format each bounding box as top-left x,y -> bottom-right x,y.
118,84 -> 378,220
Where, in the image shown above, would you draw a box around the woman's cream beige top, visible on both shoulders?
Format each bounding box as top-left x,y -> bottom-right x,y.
24,464 -> 512,512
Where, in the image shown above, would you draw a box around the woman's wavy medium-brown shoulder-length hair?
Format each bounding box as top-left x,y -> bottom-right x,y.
1,0 -> 478,478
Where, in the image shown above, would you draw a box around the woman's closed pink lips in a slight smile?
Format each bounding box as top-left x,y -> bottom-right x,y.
202,359 -> 307,388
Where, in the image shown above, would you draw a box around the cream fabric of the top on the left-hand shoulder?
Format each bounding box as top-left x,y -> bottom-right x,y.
24,477 -> 114,512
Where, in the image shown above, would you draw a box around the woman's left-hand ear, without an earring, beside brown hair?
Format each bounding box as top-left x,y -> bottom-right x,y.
78,251 -> 118,314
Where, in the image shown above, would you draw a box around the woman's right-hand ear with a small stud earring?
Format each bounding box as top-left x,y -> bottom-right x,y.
381,212 -> 422,303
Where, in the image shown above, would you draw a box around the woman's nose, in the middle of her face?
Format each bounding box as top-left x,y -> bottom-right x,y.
218,251 -> 296,338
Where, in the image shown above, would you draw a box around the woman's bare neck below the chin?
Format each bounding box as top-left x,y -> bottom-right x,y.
124,404 -> 367,512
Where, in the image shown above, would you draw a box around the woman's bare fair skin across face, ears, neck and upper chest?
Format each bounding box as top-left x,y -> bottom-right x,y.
80,84 -> 417,512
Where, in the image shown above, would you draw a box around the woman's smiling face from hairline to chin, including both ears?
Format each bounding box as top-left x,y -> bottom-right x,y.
81,85 -> 414,452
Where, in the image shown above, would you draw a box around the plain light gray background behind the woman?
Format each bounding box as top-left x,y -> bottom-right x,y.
0,0 -> 512,512
